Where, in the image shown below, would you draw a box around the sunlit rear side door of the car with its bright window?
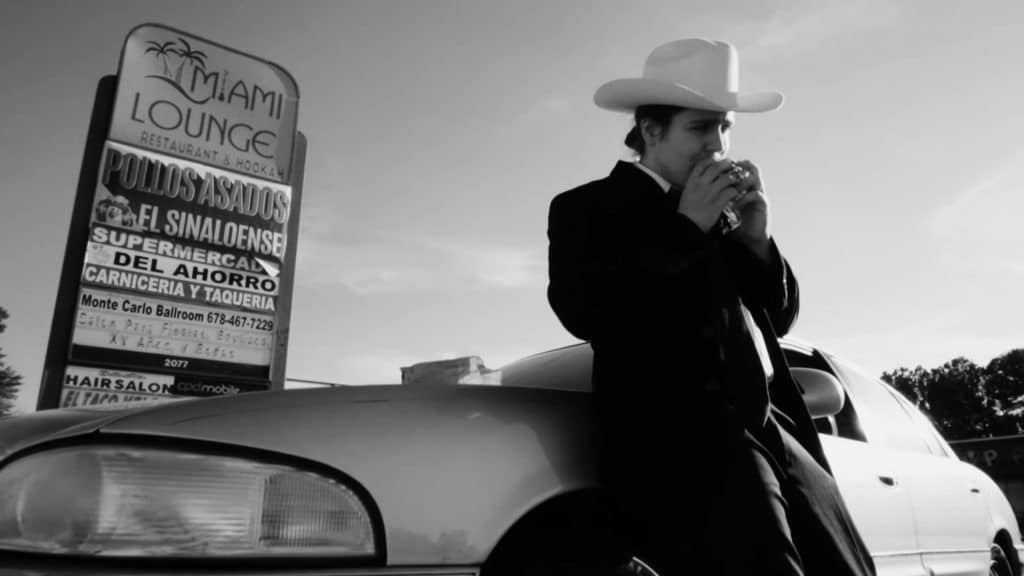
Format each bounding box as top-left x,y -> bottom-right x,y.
833,359 -> 993,576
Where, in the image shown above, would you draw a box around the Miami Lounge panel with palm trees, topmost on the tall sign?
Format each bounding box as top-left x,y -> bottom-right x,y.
110,25 -> 299,182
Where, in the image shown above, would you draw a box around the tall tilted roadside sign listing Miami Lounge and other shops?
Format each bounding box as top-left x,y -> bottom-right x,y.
38,25 -> 305,409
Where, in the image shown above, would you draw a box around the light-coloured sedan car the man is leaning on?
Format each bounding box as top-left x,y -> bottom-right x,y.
0,339 -> 1022,576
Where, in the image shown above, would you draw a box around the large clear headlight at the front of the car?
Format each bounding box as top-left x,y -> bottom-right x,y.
0,446 -> 376,558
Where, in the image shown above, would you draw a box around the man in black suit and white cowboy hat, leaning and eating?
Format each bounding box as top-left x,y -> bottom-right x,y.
548,39 -> 874,576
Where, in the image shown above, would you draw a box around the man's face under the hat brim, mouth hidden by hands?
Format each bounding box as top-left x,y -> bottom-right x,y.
644,110 -> 735,188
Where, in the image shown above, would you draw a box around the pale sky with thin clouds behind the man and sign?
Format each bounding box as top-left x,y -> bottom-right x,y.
0,0 -> 1024,411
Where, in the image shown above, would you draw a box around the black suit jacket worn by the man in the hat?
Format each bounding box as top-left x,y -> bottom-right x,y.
548,162 -> 829,470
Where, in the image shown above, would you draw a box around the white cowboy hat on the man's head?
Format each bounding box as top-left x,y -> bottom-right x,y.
594,38 -> 782,112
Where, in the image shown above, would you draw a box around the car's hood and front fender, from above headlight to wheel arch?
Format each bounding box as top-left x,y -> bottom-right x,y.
0,385 -> 594,564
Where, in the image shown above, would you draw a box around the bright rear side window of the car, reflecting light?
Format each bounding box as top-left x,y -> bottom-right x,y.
834,359 -> 932,454
